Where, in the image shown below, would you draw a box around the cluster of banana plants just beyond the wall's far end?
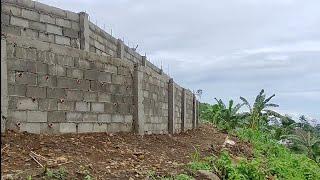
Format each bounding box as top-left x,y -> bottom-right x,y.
200,89 -> 282,130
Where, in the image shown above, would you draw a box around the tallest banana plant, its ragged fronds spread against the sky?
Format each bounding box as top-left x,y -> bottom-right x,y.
240,89 -> 281,129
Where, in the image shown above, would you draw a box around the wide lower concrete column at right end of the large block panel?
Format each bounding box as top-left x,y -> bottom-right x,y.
133,65 -> 144,135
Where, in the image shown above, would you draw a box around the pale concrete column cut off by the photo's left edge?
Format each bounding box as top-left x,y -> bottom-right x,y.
1,37 -> 9,133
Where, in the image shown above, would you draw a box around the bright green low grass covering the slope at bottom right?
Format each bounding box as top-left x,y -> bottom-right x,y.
187,129 -> 320,180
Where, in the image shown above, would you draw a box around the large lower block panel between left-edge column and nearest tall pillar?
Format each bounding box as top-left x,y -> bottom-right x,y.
1,34 -> 133,133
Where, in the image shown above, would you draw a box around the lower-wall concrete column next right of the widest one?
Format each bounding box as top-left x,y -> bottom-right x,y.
168,78 -> 175,134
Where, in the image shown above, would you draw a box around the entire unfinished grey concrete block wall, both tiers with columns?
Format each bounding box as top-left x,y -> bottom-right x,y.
1,0 -> 198,134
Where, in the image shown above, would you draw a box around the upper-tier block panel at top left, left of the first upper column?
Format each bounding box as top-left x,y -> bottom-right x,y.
1,0 -> 80,48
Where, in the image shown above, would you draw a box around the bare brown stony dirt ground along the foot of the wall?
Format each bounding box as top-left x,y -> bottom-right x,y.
1,125 -> 250,179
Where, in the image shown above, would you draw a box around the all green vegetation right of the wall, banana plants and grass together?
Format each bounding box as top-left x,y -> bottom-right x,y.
198,90 -> 320,179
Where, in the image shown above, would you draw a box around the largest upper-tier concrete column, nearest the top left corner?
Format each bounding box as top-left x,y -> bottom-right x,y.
79,12 -> 90,51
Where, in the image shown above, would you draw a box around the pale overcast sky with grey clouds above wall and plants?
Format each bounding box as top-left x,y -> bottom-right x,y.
40,0 -> 320,119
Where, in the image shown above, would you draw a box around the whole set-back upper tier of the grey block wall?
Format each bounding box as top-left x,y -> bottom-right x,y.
1,0 -> 178,72
